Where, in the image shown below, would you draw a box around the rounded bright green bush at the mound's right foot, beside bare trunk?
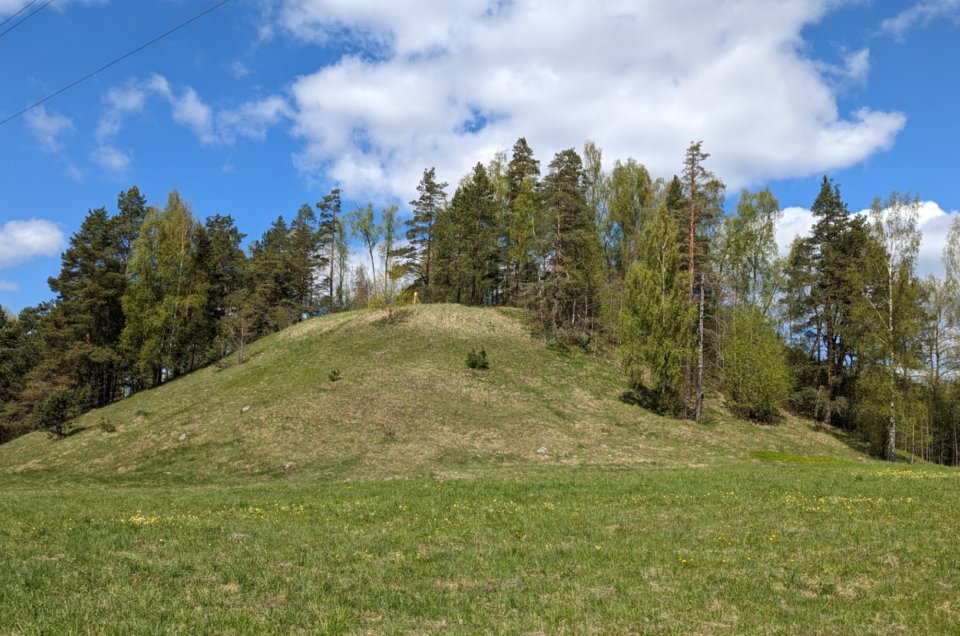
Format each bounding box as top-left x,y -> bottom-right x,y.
721,307 -> 793,422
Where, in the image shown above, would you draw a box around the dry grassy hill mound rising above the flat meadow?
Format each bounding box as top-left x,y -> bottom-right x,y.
0,305 -> 859,482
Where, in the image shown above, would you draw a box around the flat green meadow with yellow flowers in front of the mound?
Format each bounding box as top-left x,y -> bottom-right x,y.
0,454 -> 960,634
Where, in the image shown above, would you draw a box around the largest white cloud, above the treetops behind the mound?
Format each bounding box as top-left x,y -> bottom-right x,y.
278,0 -> 905,201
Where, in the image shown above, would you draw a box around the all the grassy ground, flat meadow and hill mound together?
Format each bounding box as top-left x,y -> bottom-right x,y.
0,306 -> 960,635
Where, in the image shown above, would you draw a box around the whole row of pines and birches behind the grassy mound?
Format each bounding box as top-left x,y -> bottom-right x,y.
0,138 -> 960,465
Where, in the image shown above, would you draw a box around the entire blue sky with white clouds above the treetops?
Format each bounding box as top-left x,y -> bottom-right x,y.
0,0 -> 960,311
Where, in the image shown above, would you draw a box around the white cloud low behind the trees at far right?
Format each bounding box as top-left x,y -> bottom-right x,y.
776,201 -> 960,277
